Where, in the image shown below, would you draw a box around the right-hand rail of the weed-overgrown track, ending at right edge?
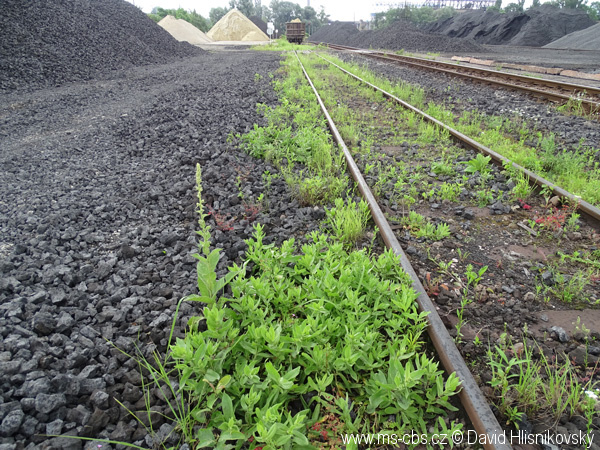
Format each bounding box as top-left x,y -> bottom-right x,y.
317,54 -> 600,221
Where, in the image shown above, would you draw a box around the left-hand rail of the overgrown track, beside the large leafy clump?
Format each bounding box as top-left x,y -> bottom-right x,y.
294,51 -> 512,450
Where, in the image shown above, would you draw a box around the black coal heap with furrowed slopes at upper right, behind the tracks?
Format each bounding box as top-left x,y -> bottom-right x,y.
425,5 -> 595,47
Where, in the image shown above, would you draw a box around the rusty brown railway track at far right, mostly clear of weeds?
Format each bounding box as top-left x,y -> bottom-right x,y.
314,43 -> 600,120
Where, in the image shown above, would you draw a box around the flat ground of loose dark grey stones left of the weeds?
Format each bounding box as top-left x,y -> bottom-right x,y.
0,52 -> 304,449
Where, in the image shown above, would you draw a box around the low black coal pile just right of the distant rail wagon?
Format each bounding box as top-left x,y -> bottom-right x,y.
309,21 -> 482,53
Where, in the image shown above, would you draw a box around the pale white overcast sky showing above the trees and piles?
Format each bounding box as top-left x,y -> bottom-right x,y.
128,0 -> 546,21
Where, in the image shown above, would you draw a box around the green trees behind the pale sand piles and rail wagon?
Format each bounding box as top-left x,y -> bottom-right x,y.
148,0 -> 329,34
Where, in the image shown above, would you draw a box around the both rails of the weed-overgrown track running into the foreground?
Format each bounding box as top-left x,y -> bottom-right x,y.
296,49 -> 600,450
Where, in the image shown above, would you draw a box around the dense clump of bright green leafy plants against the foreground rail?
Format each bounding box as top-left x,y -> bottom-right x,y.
170,225 -> 459,449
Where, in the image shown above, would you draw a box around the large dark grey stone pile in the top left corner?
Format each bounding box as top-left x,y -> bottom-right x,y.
0,0 -> 202,92
